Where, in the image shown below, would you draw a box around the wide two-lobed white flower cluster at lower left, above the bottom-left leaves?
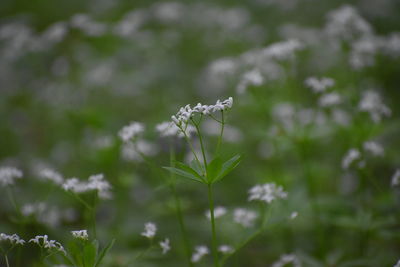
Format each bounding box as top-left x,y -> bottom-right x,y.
62,174 -> 111,199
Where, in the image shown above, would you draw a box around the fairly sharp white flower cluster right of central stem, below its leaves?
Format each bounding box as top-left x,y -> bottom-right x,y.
248,183 -> 287,203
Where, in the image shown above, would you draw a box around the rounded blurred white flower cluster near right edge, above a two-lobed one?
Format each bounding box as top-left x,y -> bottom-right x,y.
358,90 -> 392,123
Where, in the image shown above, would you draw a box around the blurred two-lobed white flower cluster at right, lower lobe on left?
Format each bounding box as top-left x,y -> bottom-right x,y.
342,141 -> 385,169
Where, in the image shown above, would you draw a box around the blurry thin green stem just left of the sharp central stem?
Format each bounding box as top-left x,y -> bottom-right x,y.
169,145 -> 193,267
